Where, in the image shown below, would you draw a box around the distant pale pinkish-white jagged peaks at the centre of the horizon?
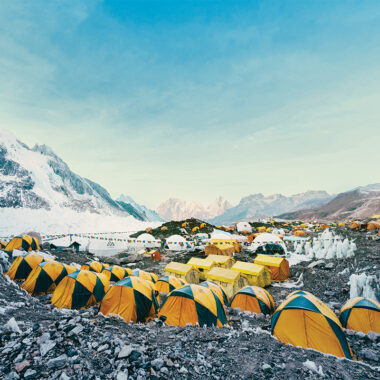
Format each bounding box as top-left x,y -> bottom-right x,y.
156,197 -> 232,220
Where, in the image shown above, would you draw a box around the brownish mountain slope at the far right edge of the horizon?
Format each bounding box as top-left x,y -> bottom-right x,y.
279,183 -> 380,220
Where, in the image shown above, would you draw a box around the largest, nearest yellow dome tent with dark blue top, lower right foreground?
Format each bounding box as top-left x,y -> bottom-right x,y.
272,294 -> 353,359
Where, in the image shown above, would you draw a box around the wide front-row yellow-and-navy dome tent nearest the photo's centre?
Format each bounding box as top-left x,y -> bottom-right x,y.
158,284 -> 228,327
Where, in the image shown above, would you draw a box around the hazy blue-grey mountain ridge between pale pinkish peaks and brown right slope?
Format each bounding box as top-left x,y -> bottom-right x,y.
211,191 -> 332,224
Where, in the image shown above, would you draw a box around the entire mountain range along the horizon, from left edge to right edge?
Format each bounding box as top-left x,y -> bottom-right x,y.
0,130 -> 380,229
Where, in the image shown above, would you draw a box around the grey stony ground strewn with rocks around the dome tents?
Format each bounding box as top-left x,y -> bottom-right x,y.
0,229 -> 380,380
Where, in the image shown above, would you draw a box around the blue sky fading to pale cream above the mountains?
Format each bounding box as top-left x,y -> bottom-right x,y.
0,0 -> 380,207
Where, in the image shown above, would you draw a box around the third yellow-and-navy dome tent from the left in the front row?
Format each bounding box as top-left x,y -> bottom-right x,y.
21,261 -> 76,294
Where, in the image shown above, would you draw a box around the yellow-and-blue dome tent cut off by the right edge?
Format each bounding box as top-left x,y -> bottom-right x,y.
339,297 -> 380,334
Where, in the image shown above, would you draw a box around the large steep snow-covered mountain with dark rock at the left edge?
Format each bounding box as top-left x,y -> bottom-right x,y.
0,130 -> 160,221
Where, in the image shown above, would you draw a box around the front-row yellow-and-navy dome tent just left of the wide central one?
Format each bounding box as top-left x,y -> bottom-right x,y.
99,276 -> 158,323
